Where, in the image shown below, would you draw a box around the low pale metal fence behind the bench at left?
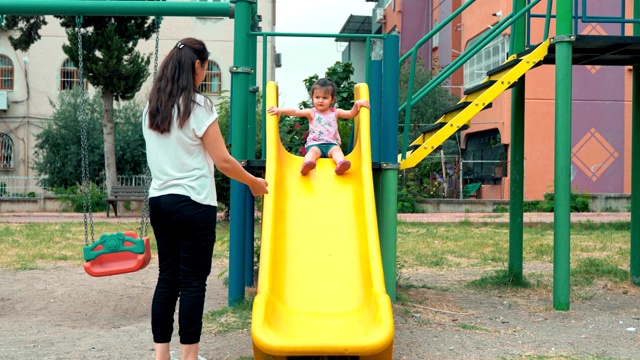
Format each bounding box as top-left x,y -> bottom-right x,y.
0,175 -> 145,199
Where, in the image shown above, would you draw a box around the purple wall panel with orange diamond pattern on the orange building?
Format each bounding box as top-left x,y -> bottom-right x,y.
571,0 -> 625,193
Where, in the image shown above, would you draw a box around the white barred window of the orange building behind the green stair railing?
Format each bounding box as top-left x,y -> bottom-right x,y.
464,34 -> 509,88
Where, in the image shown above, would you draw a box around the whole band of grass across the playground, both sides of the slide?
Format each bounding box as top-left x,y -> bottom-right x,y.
0,220 -> 630,294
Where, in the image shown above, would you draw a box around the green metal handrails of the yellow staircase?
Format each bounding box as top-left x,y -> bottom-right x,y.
398,0 -> 549,159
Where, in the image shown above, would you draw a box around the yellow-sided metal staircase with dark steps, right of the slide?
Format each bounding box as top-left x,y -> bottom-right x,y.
398,40 -> 550,169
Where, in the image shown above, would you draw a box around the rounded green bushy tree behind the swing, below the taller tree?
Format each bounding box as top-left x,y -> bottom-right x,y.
33,90 -> 146,188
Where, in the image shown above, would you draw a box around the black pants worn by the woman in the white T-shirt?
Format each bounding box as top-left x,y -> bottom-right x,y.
149,195 -> 217,344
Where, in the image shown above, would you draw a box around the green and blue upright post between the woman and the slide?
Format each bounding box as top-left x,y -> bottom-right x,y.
228,0 -> 255,306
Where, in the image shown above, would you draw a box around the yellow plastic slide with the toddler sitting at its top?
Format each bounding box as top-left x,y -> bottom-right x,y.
251,82 -> 394,360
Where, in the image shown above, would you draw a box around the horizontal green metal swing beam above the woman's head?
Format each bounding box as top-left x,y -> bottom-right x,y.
0,0 -> 233,17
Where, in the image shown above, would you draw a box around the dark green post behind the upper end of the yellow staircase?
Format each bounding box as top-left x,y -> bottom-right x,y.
509,0 -> 527,282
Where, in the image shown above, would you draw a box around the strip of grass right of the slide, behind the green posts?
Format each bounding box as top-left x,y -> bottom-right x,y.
397,220 -> 630,281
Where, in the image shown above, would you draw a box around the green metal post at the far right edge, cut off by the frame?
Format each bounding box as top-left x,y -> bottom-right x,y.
629,0 -> 640,286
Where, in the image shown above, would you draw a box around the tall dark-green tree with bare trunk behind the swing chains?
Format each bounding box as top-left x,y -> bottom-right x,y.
6,16 -> 155,195
